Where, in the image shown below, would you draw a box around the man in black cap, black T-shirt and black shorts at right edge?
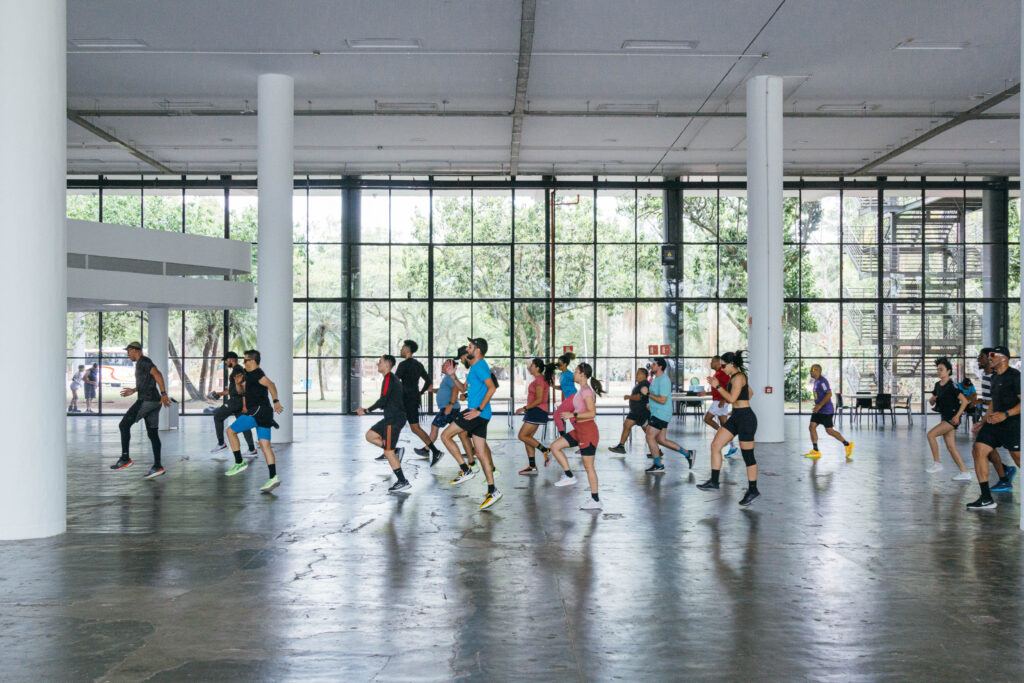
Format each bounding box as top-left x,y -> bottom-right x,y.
967,346 -> 1021,510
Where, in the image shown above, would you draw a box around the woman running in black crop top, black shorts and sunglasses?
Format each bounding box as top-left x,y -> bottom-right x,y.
697,351 -> 761,507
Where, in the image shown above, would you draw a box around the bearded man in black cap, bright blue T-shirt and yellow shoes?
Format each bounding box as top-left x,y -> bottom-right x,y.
441,337 -> 502,510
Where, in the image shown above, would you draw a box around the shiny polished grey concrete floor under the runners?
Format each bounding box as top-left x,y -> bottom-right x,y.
0,417 -> 1024,681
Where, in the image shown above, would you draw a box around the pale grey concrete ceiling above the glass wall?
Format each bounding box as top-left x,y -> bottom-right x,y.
68,0 -> 1020,175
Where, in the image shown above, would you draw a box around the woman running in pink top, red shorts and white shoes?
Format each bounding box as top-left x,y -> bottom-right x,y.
551,362 -> 604,510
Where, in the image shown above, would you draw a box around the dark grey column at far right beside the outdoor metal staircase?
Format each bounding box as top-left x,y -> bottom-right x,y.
981,177 -> 1010,346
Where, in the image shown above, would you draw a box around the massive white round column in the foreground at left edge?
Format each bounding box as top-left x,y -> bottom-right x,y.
0,0 -> 68,540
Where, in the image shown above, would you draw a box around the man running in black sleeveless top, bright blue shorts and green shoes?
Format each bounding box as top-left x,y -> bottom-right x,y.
224,349 -> 285,494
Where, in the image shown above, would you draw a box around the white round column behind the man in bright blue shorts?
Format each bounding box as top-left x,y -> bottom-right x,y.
256,74 -> 295,443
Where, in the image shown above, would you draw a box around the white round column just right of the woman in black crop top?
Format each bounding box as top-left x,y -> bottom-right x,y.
746,76 -> 785,443
